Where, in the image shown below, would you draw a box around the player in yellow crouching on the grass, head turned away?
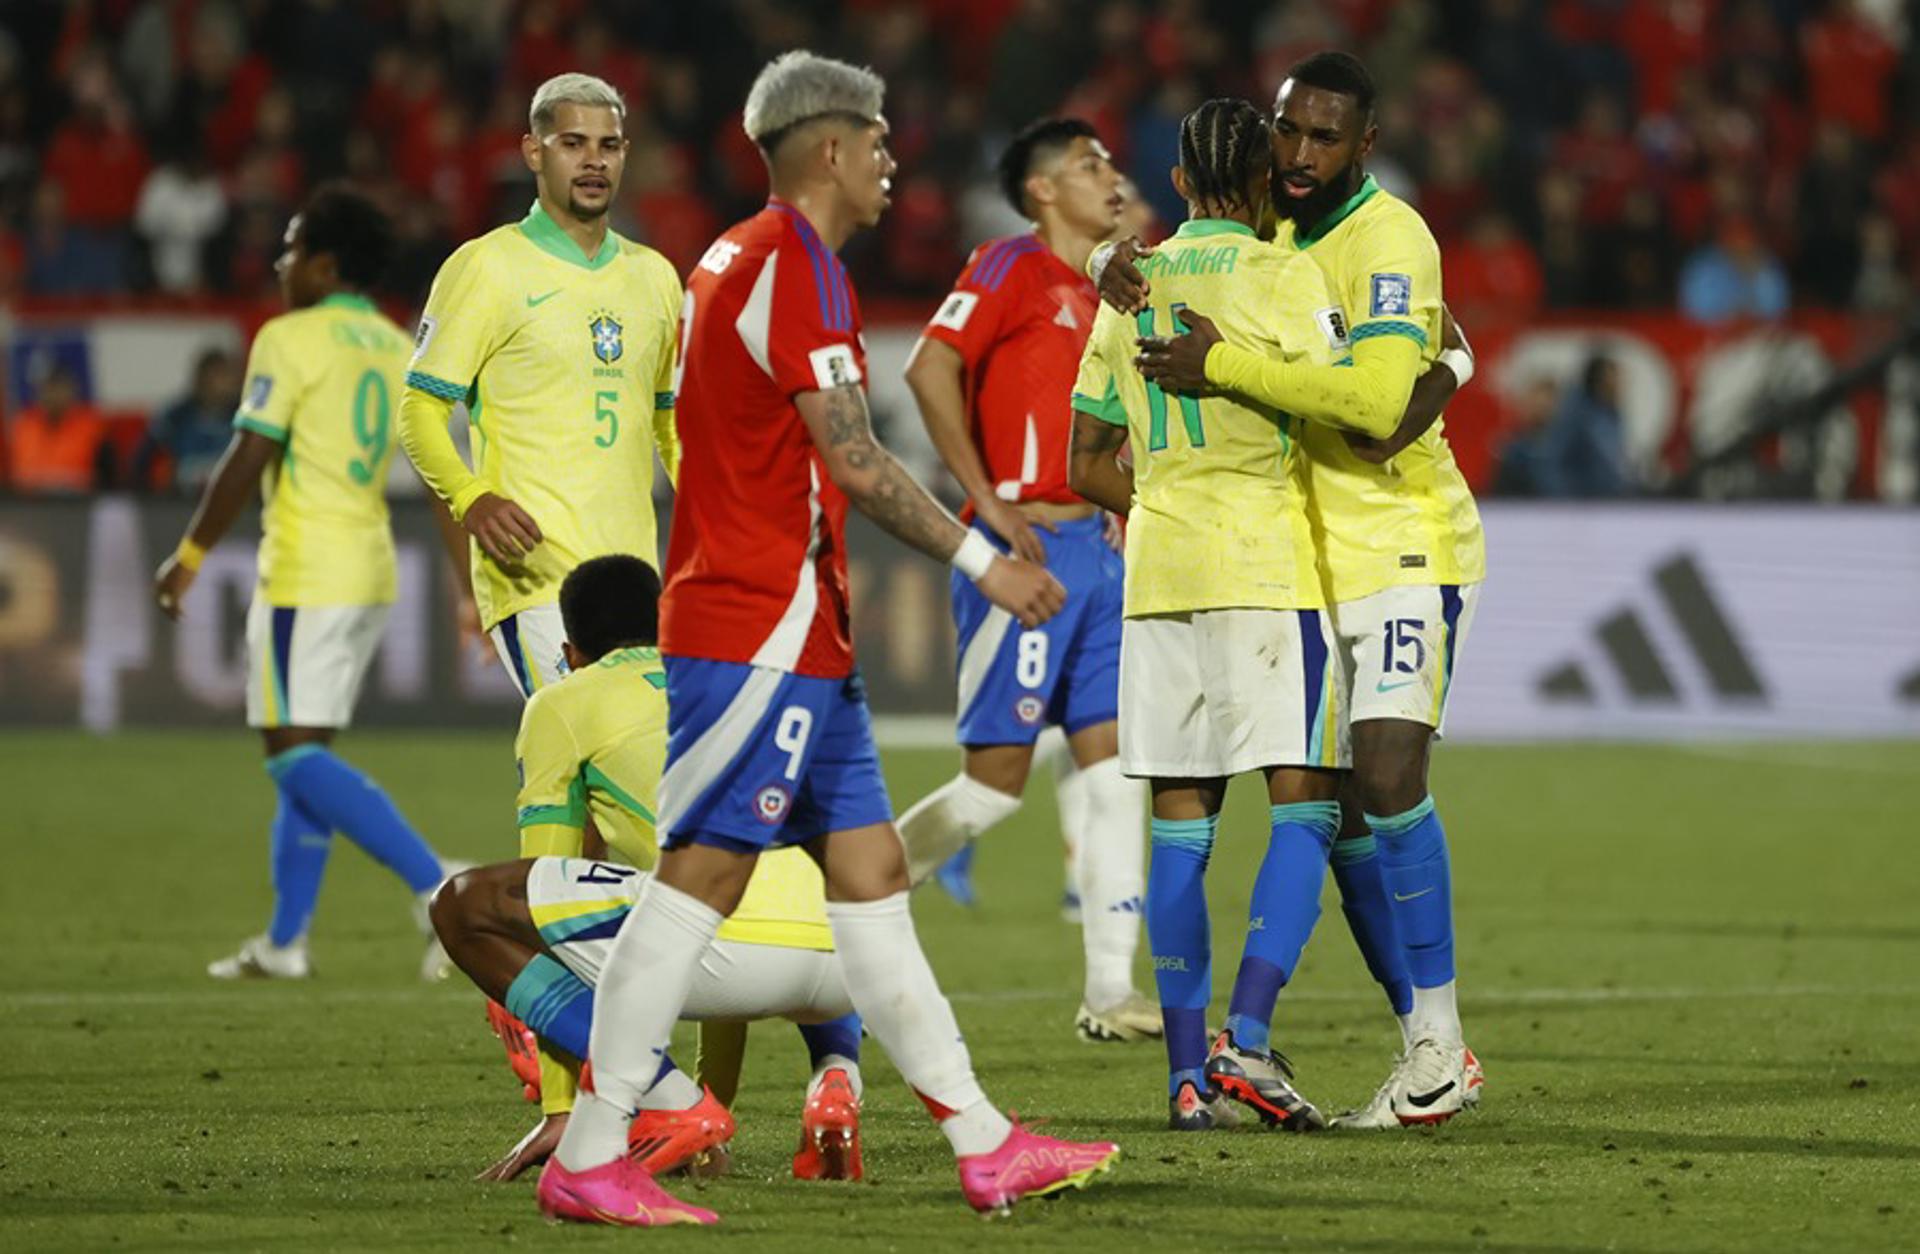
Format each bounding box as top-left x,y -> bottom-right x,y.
434,553 -> 860,1179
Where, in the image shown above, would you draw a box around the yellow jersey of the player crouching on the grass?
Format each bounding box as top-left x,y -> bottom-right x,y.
515,647 -> 833,949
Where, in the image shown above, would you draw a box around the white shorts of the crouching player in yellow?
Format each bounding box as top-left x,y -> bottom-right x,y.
526,858 -> 852,1024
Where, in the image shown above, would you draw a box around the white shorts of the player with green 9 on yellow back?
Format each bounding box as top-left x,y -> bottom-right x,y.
246,595 -> 392,728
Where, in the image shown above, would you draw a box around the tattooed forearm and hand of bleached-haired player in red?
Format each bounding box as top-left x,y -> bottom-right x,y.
793,384 -> 1068,628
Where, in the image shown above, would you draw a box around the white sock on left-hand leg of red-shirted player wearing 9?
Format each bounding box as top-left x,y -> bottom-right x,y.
555,880 -> 722,1171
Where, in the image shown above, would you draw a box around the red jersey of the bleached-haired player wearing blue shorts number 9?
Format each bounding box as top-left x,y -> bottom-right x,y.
660,200 -> 866,678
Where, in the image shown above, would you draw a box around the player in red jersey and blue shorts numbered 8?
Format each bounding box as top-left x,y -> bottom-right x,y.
900,117 -> 1160,1041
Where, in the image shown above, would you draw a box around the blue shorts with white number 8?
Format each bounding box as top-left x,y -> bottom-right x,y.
952,515 -> 1125,745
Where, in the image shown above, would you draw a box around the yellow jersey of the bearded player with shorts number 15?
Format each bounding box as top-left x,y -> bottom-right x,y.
1279,175 -> 1486,601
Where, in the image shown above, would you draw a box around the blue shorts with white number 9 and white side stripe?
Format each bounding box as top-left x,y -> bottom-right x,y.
659,657 -> 893,853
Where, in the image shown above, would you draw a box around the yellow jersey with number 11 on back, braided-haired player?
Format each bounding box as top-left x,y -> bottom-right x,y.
1073,219 -> 1336,618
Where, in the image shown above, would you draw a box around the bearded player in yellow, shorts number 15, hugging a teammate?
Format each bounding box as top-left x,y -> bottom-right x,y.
1142,52 -> 1486,1127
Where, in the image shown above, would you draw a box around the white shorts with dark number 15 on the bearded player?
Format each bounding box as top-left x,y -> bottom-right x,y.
1332,584 -> 1480,734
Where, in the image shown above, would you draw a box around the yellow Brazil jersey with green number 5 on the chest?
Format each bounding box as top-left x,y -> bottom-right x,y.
407,205 -> 682,626
